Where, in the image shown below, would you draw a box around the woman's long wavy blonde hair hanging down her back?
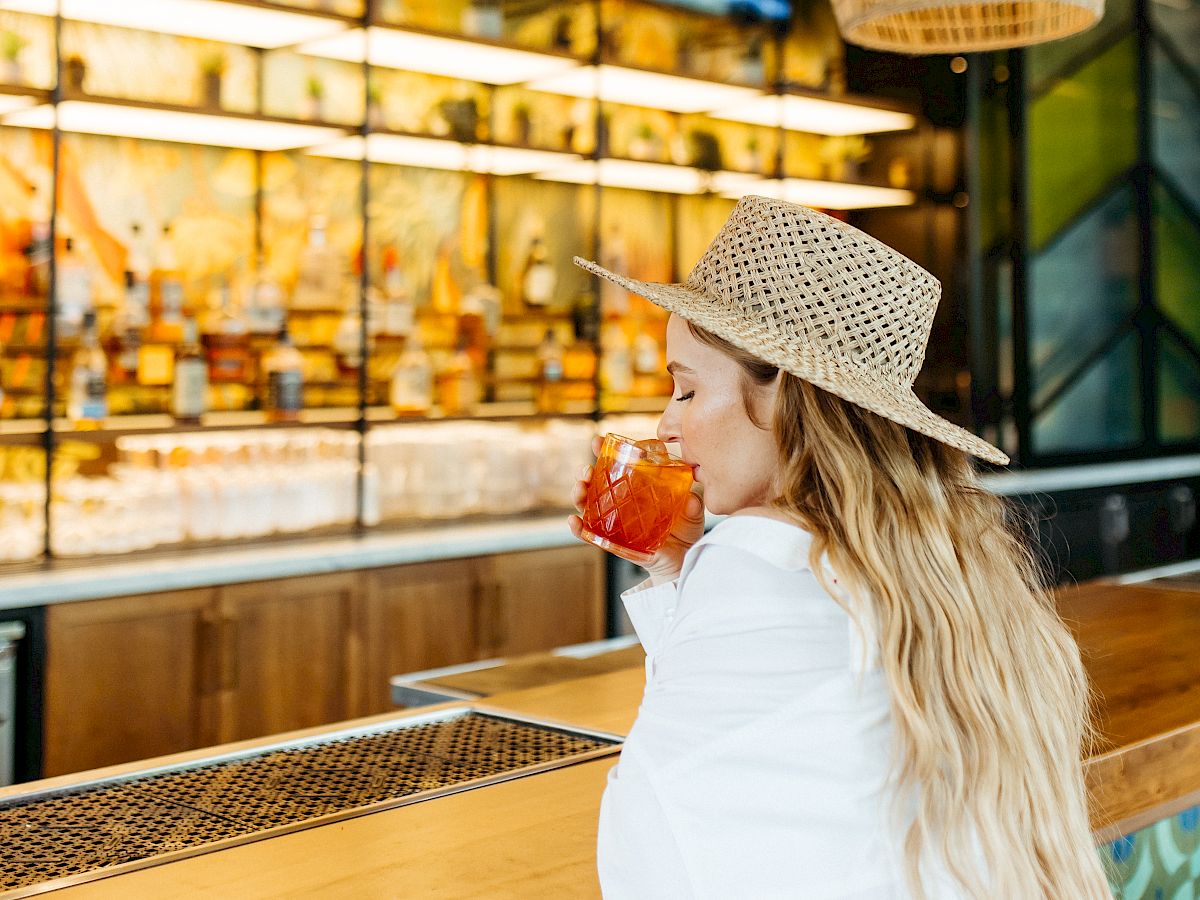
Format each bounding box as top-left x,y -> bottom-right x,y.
691,326 -> 1111,900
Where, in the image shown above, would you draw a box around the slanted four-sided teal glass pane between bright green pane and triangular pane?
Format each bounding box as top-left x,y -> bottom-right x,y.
1026,187 -> 1139,409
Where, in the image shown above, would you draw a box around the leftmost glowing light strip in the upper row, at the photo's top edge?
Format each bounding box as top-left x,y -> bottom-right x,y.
2,0 -> 347,49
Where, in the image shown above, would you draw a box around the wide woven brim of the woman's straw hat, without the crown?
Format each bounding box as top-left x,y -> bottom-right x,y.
575,257 -> 1009,466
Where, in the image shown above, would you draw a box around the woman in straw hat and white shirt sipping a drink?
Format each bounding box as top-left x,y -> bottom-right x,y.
571,197 -> 1110,900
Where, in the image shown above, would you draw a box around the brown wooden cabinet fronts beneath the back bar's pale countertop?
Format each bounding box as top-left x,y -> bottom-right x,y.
43,546 -> 605,775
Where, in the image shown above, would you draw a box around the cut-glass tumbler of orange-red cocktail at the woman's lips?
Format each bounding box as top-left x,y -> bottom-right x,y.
581,434 -> 691,564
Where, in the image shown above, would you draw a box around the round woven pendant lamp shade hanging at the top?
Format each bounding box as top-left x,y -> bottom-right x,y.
833,0 -> 1104,54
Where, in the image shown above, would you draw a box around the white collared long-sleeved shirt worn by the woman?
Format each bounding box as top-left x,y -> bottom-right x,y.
598,516 -> 956,900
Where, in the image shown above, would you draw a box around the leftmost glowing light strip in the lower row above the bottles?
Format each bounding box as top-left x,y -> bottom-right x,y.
4,100 -> 344,150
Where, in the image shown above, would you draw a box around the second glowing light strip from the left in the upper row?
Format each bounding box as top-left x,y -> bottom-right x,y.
298,26 -> 577,84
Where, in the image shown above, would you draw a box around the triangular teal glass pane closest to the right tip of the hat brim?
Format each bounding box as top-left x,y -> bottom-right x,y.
1032,331 -> 1144,454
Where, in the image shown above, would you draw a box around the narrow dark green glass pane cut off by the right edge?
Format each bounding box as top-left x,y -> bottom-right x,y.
1154,181 -> 1200,343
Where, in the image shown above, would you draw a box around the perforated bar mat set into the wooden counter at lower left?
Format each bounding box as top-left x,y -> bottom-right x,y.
0,709 -> 619,896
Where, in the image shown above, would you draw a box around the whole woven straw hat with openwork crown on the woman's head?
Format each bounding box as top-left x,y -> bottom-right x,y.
575,196 -> 1008,464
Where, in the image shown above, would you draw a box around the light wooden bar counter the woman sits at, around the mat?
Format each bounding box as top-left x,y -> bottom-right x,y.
0,574 -> 1200,900
